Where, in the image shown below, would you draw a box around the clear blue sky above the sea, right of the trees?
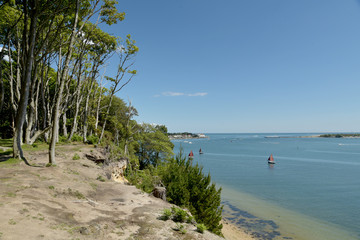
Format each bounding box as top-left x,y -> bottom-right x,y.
100,0 -> 360,133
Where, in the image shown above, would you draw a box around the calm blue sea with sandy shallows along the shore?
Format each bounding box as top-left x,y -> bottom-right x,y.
173,134 -> 360,240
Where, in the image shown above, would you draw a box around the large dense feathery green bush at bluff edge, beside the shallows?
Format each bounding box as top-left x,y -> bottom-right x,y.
159,151 -> 222,235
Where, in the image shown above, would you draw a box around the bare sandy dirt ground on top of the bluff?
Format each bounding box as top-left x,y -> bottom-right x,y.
0,144 -> 253,240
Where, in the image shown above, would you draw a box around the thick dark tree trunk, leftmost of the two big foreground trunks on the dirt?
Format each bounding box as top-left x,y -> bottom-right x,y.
13,0 -> 38,159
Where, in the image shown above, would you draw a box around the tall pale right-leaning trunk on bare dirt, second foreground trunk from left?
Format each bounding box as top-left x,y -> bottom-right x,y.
49,0 -> 79,164
